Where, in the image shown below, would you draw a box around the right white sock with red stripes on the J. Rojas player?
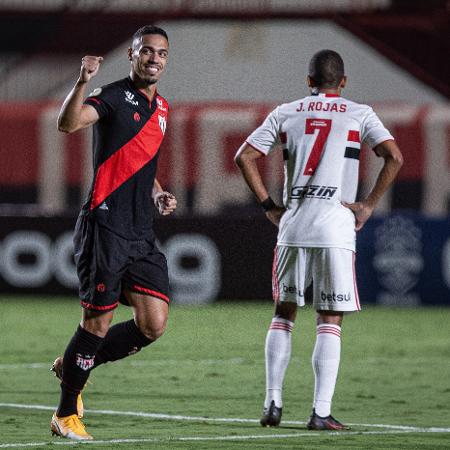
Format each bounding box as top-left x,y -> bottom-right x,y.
312,323 -> 341,417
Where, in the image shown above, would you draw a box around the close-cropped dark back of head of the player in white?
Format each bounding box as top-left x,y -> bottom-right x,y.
308,50 -> 345,88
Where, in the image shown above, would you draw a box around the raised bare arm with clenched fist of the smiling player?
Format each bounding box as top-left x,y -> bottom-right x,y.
58,56 -> 103,133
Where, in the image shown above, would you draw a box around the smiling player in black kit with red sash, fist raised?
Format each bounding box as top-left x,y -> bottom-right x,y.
50,25 -> 177,440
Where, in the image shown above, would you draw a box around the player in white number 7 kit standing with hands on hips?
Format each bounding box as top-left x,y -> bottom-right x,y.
235,50 -> 403,430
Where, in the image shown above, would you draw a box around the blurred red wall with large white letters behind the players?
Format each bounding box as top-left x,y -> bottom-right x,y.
0,102 -> 450,216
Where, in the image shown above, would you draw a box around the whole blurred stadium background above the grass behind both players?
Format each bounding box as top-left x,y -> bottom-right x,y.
0,0 -> 450,306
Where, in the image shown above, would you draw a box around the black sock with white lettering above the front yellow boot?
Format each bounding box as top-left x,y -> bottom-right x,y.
56,326 -> 103,417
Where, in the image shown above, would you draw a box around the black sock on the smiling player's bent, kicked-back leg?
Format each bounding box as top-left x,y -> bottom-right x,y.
94,320 -> 153,367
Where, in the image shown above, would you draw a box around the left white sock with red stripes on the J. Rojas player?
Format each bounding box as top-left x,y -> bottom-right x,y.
264,317 -> 294,408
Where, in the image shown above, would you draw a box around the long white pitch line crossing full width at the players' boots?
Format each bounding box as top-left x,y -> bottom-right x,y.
0,403 -> 450,436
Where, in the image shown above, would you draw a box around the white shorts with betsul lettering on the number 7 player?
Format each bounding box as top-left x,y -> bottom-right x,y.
272,245 -> 361,311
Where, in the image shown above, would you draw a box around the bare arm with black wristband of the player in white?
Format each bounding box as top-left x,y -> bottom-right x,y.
234,143 -> 285,226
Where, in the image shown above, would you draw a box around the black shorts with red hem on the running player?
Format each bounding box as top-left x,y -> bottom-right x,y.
74,211 -> 169,311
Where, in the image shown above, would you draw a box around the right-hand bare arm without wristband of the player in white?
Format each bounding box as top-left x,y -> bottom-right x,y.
342,139 -> 403,231
